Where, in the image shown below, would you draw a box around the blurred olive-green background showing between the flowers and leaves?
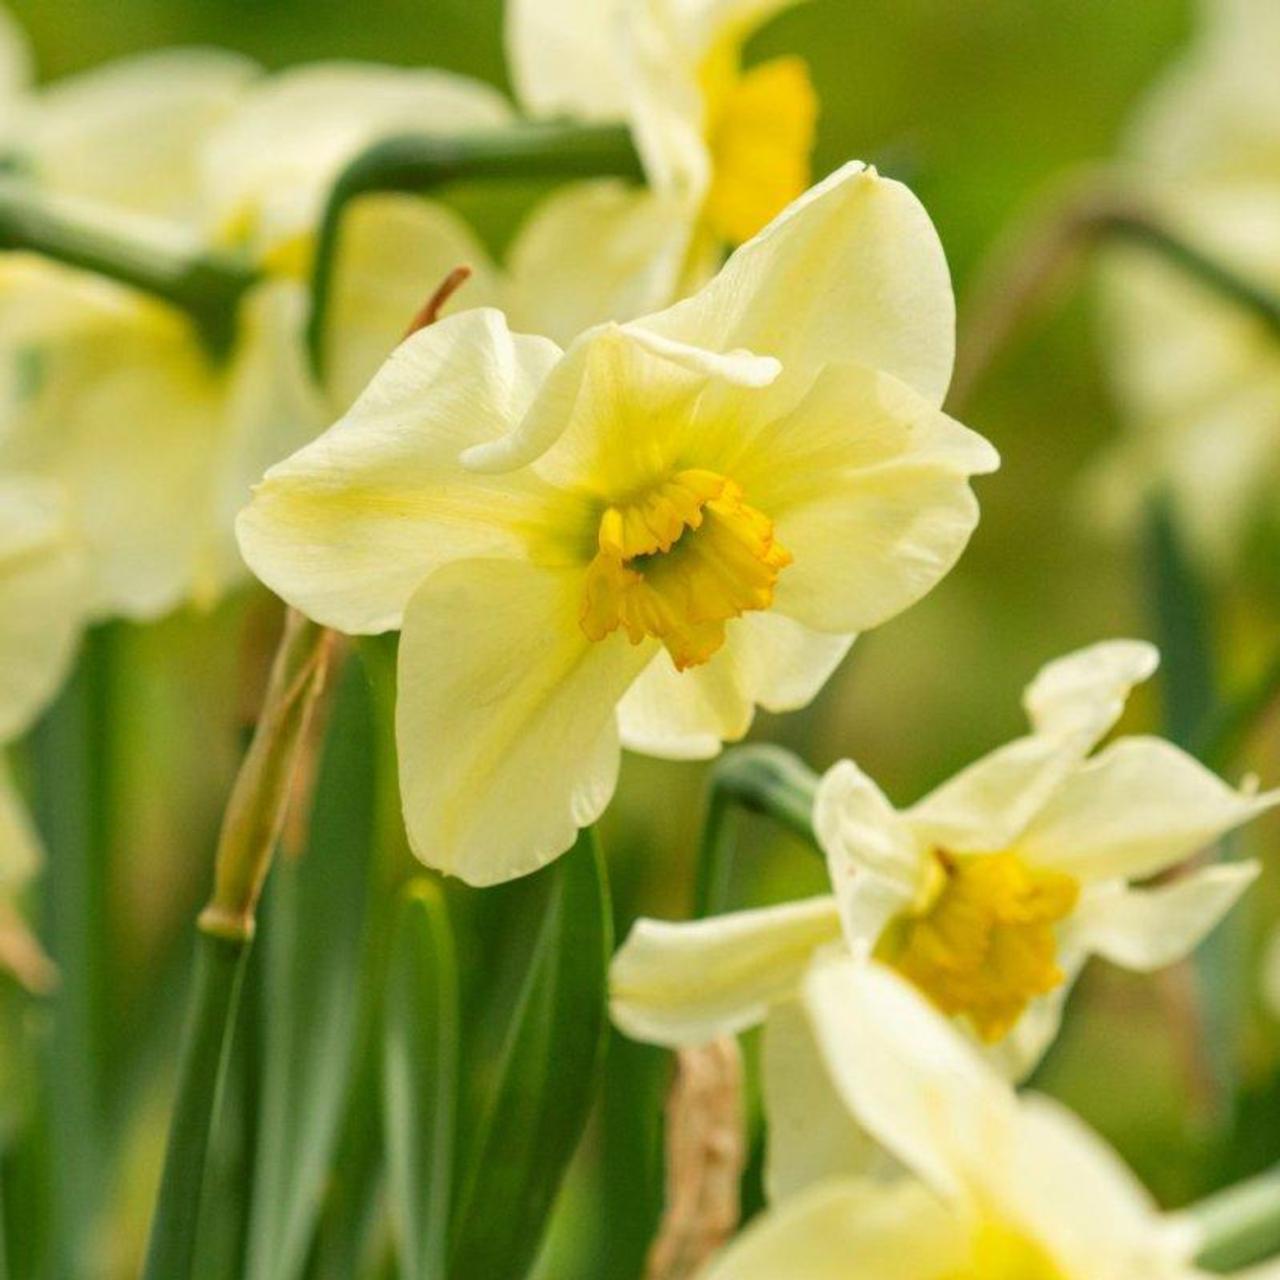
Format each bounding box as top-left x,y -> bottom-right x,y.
10,0 -> 1280,1275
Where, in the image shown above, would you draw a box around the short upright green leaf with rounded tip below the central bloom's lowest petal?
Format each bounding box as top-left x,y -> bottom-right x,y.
383,879 -> 458,1280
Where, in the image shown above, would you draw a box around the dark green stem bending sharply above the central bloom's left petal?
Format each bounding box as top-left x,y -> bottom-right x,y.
307,124 -> 644,375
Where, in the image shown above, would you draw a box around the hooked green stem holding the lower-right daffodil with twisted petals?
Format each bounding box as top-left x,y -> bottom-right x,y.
694,745 -> 818,919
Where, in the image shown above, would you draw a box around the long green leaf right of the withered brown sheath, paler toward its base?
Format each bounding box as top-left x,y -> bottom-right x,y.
246,659 -> 375,1280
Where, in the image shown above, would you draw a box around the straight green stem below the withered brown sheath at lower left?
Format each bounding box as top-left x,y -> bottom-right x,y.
142,933 -> 250,1280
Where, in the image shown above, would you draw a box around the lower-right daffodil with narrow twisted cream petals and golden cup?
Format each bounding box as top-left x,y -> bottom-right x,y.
611,641 -> 1280,1185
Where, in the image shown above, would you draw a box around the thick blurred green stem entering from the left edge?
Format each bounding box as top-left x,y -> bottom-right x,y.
0,178 -> 259,355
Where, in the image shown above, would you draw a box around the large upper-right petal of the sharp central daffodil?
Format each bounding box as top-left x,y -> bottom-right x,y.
640,164 -> 955,406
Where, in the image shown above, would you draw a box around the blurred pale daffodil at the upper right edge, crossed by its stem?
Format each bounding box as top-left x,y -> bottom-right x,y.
1087,0 -> 1280,567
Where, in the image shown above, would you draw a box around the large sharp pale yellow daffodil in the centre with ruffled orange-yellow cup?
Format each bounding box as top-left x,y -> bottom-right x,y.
239,165 -> 997,884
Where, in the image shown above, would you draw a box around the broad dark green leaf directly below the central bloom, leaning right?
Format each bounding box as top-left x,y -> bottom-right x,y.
449,831 -> 613,1280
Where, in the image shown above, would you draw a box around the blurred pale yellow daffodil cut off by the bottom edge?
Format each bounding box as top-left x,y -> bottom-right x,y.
707,963 -> 1277,1280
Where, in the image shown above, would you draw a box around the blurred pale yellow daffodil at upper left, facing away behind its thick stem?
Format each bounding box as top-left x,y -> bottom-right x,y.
0,50 -> 325,618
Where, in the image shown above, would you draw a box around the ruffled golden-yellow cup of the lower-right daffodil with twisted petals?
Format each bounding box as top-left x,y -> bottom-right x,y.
877,850 -> 1079,1043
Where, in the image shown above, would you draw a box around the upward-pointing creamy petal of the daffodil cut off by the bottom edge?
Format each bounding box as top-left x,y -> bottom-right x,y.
804,960 -> 1016,1197
